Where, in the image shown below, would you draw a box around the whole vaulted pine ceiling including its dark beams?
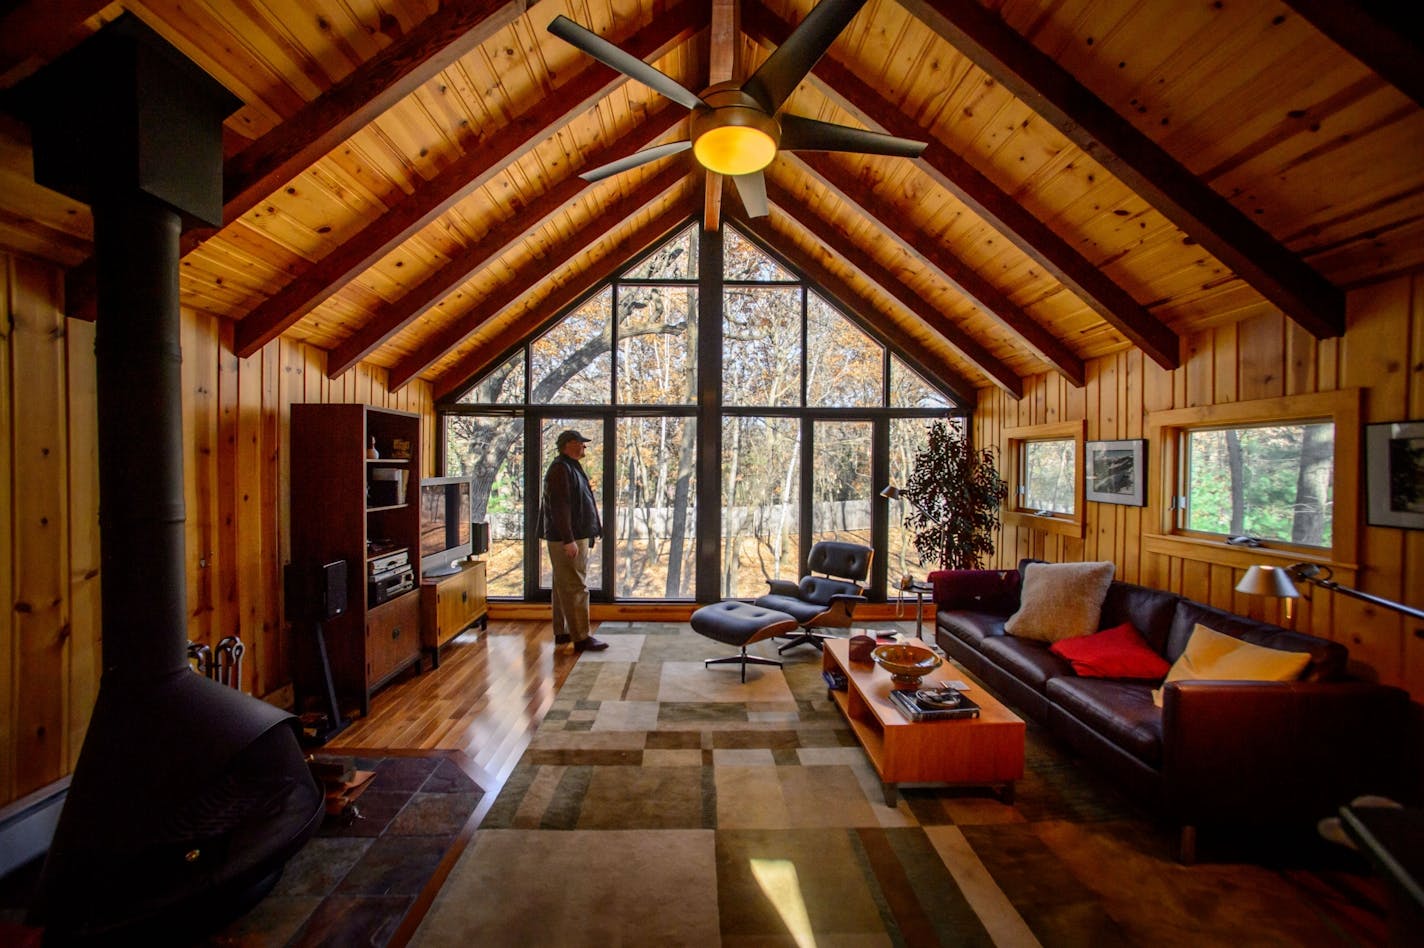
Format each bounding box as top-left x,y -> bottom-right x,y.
0,0 -> 1424,399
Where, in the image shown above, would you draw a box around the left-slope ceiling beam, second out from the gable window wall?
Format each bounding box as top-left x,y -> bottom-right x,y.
389,161 -> 688,390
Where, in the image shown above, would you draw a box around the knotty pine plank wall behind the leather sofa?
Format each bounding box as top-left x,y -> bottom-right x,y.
974,275 -> 1424,702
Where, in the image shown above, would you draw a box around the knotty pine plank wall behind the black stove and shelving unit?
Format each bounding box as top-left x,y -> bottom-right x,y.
0,255 -> 434,807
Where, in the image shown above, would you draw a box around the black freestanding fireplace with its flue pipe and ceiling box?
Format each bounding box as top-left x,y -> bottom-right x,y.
13,16 -> 323,945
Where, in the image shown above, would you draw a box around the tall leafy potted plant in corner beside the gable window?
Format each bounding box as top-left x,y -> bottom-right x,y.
900,421 -> 1008,569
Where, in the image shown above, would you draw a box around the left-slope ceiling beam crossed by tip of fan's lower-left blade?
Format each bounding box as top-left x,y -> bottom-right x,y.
326,107 -> 686,379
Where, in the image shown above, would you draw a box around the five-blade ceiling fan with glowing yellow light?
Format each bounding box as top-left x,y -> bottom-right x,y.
548,0 -> 926,218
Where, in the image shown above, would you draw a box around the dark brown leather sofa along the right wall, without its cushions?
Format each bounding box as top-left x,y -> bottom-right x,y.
928,561 -> 1410,863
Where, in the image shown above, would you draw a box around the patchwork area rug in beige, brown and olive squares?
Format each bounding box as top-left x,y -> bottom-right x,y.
413,623 -> 1384,947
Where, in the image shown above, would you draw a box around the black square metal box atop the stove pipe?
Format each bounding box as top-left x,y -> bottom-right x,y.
11,14 -> 242,226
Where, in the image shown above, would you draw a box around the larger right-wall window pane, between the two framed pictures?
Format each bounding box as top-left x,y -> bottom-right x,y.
1182,421 -> 1334,547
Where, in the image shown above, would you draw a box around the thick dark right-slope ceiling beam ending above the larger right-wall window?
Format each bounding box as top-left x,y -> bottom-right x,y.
900,0 -> 1344,339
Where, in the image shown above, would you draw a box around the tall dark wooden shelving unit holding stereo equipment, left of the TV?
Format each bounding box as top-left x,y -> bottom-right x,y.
289,404 -> 420,715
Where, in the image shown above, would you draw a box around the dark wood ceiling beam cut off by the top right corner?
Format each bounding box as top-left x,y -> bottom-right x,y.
1286,0 -> 1424,105
